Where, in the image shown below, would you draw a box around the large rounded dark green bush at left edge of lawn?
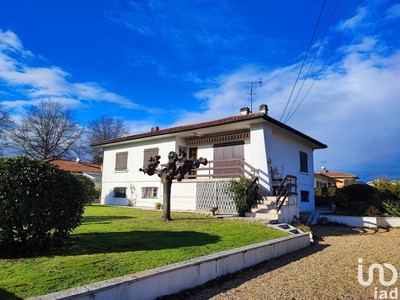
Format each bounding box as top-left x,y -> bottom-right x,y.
0,157 -> 85,256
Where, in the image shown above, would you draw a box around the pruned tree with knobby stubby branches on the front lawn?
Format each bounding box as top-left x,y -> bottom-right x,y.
139,151 -> 207,221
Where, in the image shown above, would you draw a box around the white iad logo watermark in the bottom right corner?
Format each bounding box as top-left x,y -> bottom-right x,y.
358,258 -> 399,299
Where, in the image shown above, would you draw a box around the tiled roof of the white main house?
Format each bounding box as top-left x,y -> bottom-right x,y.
90,112 -> 328,148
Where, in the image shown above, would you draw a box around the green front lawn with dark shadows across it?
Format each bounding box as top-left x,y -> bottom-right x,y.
0,206 -> 287,299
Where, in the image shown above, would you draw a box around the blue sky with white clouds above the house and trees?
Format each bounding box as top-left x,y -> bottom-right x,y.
0,0 -> 400,182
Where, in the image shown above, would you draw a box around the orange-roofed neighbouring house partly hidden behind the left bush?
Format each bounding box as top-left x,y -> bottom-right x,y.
47,158 -> 102,189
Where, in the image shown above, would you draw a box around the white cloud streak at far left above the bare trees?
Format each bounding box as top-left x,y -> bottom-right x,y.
0,30 -> 139,115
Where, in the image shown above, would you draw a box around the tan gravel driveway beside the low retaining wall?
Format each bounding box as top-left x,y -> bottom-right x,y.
162,226 -> 400,300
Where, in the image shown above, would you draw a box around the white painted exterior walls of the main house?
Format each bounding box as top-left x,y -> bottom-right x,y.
101,123 -> 315,211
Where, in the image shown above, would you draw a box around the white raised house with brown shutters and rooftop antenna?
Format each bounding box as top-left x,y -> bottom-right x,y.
91,104 -> 327,212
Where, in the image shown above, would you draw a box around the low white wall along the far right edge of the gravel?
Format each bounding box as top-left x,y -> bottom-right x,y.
320,214 -> 400,227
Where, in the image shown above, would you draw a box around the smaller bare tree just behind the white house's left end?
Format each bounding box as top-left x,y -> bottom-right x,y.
86,116 -> 129,164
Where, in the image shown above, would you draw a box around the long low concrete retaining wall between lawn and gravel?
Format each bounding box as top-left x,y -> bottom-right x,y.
32,233 -> 310,300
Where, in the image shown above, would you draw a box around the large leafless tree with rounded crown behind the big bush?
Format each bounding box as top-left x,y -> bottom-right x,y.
10,100 -> 83,159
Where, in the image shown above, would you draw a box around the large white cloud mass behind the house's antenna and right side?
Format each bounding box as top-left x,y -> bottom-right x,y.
170,37 -> 400,180
